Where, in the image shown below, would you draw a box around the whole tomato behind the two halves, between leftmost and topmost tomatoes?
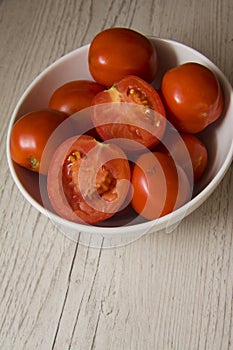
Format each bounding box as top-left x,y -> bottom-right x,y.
49,80 -> 104,115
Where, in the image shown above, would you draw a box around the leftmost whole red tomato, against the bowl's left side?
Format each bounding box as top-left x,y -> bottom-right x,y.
10,109 -> 68,174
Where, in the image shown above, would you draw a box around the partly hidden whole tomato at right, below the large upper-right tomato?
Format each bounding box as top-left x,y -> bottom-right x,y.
158,132 -> 208,182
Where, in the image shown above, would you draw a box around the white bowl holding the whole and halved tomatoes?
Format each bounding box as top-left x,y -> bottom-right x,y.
7,38 -> 233,247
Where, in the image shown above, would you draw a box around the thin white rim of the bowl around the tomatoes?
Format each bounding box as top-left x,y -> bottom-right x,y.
6,36 -> 233,236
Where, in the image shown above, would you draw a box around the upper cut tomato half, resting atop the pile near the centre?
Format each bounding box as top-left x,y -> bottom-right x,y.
92,76 -> 166,150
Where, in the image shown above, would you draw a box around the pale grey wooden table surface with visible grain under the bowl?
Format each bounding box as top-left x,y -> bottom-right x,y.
0,0 -> 233,350
